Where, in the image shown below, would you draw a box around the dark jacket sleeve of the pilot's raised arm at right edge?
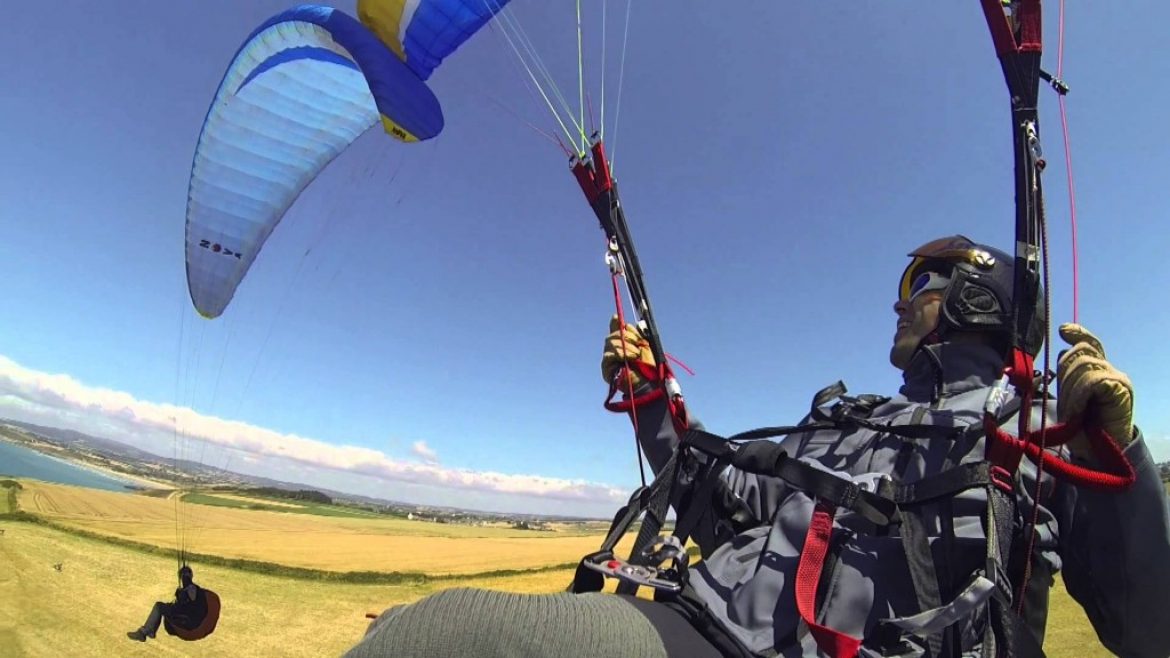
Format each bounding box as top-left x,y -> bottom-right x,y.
1060,432 -> 1170,658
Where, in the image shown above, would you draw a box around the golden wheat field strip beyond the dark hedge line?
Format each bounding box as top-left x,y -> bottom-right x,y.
19,480 -> 633,575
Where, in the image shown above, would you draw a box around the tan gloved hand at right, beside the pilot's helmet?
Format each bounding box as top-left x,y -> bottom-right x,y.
1057,323 -> 1134,457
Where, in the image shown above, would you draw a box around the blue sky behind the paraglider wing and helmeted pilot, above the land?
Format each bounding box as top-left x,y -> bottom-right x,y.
0,0 -> 1170,515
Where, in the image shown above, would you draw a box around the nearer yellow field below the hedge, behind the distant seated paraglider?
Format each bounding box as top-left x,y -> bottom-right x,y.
0,520 -> 585,658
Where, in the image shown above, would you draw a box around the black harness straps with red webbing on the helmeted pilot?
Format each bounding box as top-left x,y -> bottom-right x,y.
569,382 -> 1135,658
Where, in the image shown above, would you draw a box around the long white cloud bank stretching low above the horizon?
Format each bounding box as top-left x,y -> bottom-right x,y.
0,356 -> 628,509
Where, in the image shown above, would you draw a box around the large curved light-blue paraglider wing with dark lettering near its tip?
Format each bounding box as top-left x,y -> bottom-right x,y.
186,6 -> 443,317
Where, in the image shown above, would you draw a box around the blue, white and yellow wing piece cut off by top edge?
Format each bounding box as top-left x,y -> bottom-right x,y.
358,0 -> 509,80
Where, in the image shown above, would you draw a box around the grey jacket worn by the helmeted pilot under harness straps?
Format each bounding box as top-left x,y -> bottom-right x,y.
638,344 -> 1170,658
